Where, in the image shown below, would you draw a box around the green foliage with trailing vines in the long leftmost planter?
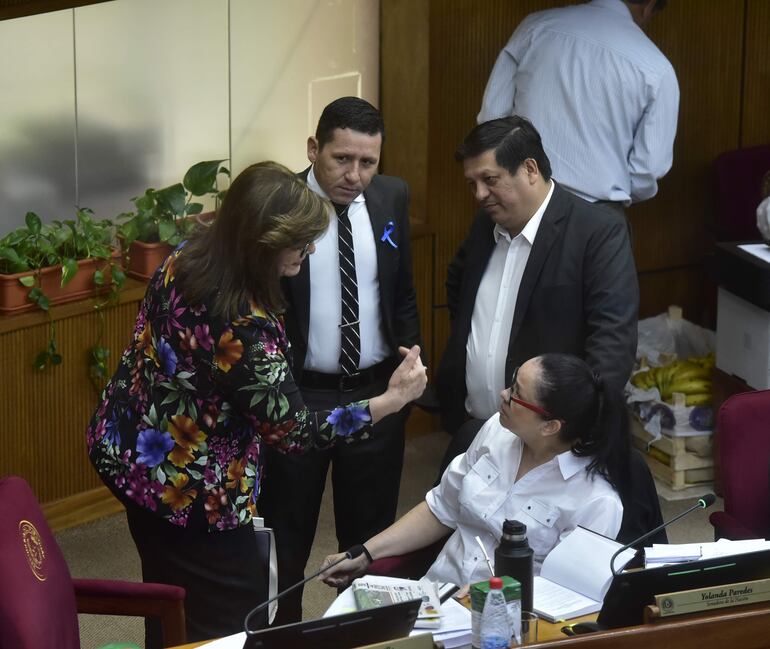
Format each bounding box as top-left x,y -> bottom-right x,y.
0,208 -> 125,370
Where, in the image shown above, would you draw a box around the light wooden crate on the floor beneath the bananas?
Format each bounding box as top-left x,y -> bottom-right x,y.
631,417 -> 714,491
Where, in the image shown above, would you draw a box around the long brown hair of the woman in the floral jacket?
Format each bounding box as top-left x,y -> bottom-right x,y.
173,162 -> 331,320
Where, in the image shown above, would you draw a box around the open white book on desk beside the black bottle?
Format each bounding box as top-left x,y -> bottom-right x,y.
534,527 -> 636,622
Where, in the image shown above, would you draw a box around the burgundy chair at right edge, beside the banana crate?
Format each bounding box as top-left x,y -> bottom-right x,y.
709,390 -> 770,540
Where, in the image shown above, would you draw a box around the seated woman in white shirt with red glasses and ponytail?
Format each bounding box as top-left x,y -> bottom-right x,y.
323,354 -> 630,587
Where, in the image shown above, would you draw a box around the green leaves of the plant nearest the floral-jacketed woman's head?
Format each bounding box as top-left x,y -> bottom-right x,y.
118,160 -> 230,246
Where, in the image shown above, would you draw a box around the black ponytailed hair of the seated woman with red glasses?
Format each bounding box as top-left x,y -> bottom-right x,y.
537,354 -> 631,496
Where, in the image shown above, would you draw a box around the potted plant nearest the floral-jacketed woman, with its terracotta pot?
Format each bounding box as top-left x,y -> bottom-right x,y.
118,160 -> 230,279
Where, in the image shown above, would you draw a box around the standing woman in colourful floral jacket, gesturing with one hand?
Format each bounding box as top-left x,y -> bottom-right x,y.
87,162 -> 426,647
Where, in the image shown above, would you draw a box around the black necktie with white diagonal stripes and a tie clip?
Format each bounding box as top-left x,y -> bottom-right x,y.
335,205 -> 361,376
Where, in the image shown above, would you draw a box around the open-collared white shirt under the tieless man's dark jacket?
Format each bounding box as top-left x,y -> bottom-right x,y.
465,181 -> 554,419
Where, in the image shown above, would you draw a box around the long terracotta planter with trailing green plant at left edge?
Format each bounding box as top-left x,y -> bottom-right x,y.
0,208 -> 125,369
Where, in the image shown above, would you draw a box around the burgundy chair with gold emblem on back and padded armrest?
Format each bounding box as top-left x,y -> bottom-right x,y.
0,476 -> 186,649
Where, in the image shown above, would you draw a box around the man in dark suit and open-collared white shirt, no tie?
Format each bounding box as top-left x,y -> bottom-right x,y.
437,116 -> 639,471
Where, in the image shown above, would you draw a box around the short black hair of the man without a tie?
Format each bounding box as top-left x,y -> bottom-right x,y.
455,115 -> 551,180
